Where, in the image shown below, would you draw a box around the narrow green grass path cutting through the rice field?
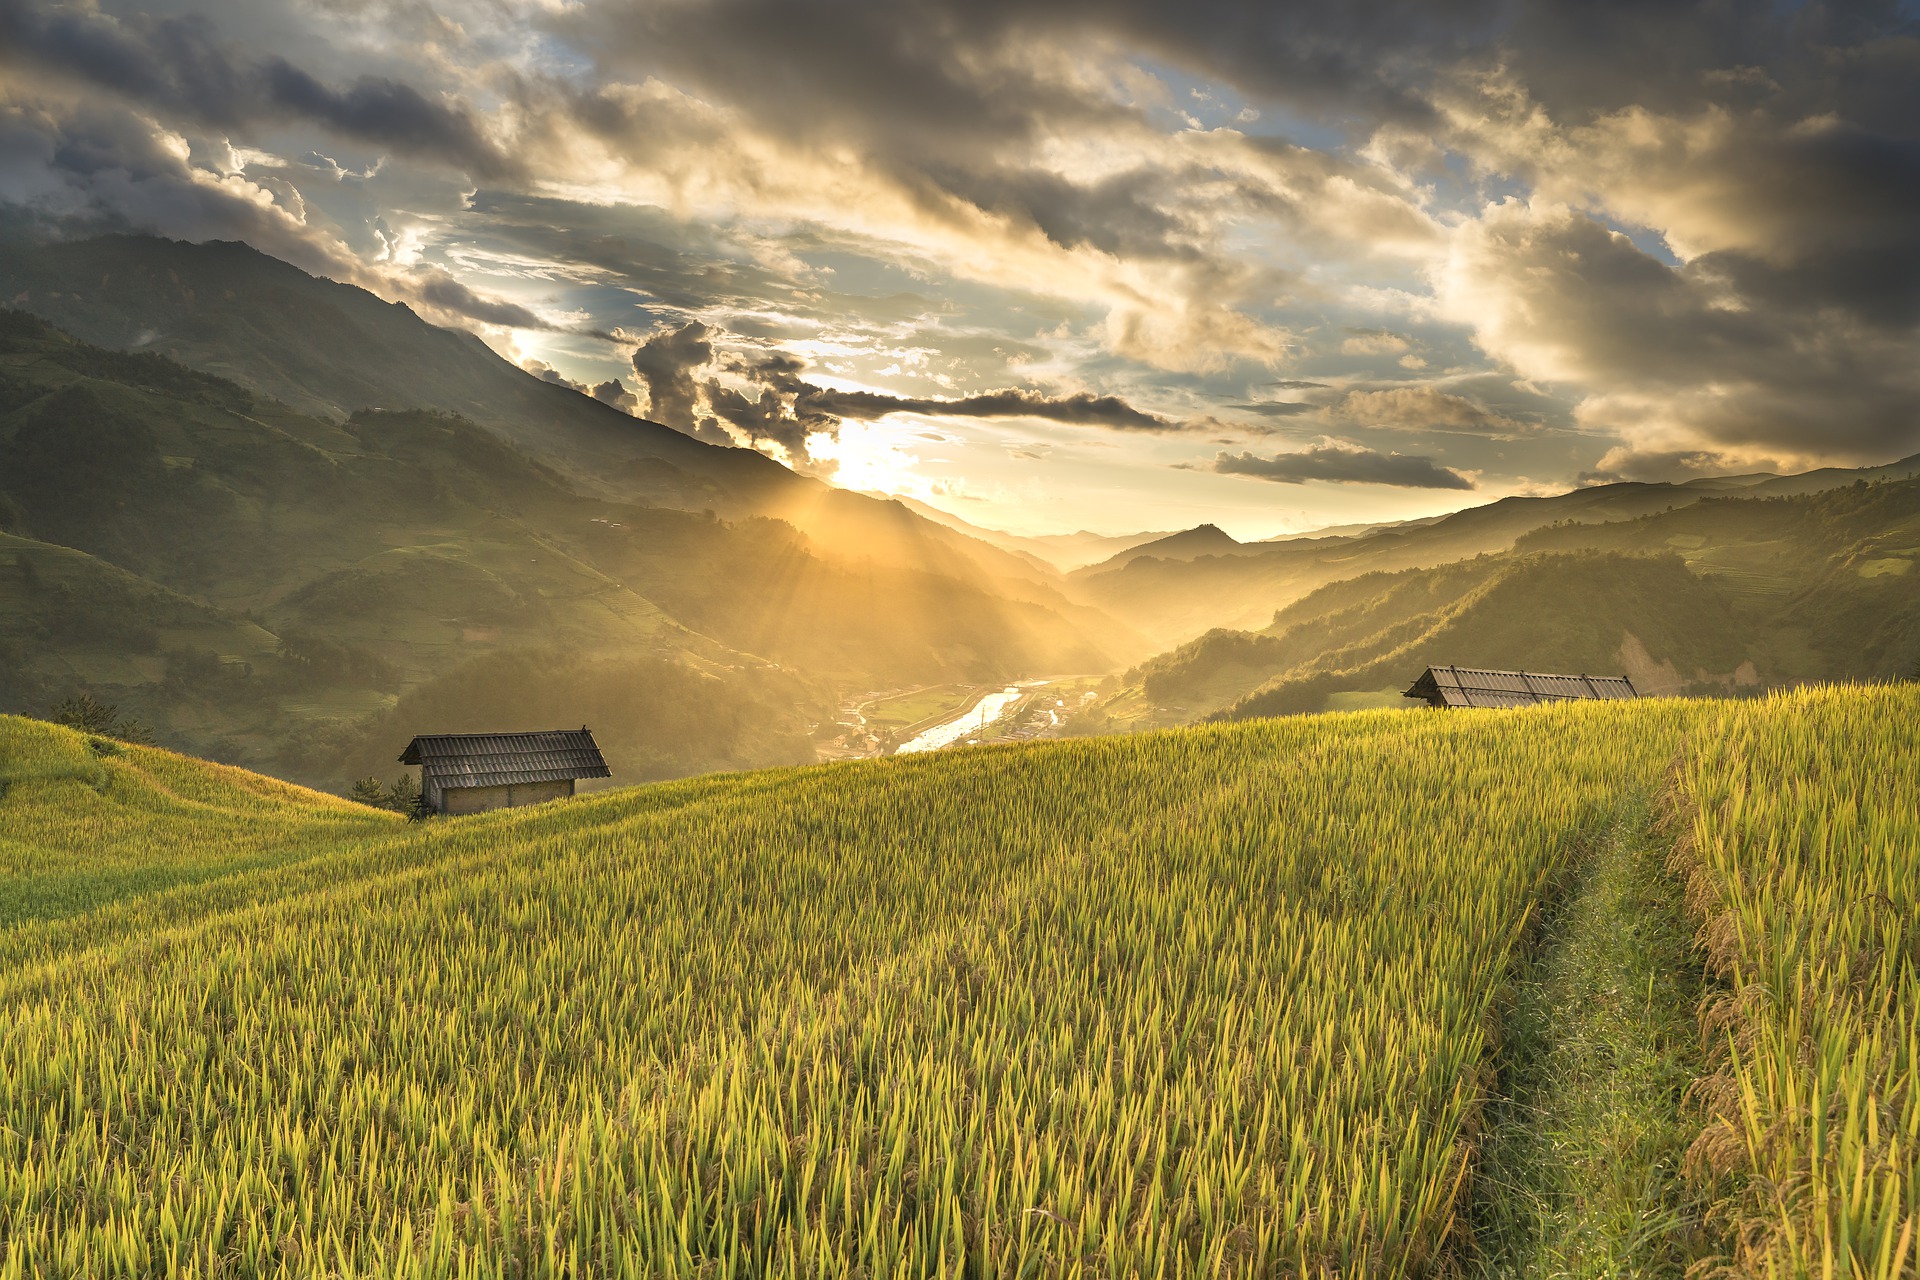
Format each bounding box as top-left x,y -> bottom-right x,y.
1473,804 -> 1705,1280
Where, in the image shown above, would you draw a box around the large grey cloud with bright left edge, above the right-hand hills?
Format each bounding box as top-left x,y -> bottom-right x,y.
1440,201 -> 1920,462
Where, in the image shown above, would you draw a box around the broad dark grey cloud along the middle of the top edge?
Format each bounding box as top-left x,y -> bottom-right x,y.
557,0 -> 1507,163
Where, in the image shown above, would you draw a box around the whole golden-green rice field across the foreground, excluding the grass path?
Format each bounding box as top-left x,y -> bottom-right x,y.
0,689 -> 1920,1278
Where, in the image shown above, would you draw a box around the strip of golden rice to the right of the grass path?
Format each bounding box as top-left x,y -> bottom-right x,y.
1676,689 -> 1920,1278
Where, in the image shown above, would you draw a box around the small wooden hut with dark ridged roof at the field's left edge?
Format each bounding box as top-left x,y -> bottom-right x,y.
399,725 -> 612,814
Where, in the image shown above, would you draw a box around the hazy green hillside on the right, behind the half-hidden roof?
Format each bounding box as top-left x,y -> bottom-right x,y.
1104,466 -> 1920,727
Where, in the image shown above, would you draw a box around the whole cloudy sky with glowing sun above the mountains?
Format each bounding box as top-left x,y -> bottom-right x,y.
0,0 -> 1920,539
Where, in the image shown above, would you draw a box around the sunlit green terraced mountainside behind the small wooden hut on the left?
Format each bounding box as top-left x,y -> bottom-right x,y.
0,313 -> 1112,785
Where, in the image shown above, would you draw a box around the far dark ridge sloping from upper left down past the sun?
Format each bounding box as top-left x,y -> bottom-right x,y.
0,236 -> 1121,637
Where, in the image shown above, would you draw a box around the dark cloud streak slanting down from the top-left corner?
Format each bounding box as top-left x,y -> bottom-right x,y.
0,0 -> 520,178
